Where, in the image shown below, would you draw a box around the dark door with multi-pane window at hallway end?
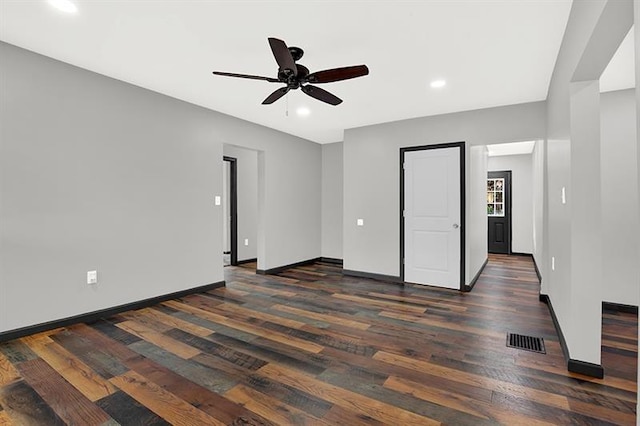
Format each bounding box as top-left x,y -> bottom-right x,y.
487,171 -> 511,254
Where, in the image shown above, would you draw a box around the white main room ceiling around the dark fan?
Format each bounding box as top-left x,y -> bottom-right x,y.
0,0 -> 571,143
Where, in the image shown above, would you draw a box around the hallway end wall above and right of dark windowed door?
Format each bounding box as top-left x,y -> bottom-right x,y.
488,154 -> 533,254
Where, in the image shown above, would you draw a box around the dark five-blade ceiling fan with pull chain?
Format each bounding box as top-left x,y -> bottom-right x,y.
213,38 -> 369,105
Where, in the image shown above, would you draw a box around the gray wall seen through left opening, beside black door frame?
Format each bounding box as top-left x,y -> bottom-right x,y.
222,144 -> 258,261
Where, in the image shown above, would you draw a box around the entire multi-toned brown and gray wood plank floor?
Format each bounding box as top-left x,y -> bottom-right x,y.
0,255 -> 637,426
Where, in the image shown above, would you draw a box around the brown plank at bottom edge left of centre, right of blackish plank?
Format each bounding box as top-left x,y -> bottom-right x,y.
110,371 -> 225,426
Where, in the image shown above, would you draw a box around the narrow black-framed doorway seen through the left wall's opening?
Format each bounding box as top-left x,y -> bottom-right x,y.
222,156 -> 238,266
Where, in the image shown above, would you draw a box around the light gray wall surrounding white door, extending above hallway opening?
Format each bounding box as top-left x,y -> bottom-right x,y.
343,102 -> 546,282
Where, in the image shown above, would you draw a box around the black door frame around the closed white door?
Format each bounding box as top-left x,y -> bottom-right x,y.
400,142 -> 464,291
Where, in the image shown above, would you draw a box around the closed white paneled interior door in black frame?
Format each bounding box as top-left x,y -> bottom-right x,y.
404,147 -> 462,289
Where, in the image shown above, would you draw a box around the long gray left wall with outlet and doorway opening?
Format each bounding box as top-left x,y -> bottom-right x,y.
0,43 -> 321,331
